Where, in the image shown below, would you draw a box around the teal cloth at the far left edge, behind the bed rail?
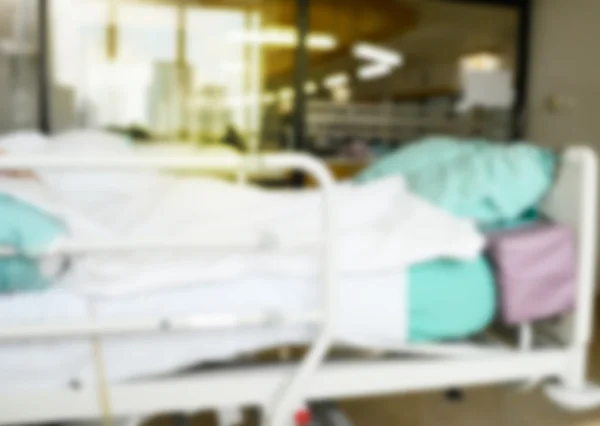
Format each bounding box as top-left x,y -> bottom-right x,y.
0,194 -> 66,293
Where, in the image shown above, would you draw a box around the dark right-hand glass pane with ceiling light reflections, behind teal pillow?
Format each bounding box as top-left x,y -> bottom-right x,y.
298,0 -> 519,160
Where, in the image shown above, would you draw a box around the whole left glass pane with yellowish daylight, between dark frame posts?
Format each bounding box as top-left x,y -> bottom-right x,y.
52,0 -> 297,150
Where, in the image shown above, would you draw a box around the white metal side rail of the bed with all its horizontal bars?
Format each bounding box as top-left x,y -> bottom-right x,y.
0,154 -> 337,426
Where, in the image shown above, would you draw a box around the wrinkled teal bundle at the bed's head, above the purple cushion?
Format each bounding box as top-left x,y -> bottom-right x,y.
356,137 -> 556,224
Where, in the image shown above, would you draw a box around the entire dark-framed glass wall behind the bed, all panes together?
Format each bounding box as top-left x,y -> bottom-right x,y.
0,0 -> 527,181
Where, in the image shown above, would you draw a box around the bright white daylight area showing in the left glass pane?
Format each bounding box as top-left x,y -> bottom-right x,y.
52,0 -> 265,150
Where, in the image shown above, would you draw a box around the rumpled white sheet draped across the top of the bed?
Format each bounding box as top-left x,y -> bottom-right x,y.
0,131 -> 484,297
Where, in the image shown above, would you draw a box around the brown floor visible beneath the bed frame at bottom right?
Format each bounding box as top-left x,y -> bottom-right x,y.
142,315 -> 600,426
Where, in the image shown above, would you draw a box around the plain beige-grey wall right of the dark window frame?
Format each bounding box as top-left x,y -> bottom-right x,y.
527,0 -> 600,152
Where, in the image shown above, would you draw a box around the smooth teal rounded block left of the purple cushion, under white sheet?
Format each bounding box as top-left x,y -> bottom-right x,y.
408,256 -> 496,342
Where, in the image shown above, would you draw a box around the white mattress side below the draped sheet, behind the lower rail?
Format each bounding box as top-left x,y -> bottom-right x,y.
0,272 -> 407,392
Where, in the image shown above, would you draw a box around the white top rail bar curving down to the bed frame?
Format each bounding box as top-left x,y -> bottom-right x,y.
0,154 -> 336,426
